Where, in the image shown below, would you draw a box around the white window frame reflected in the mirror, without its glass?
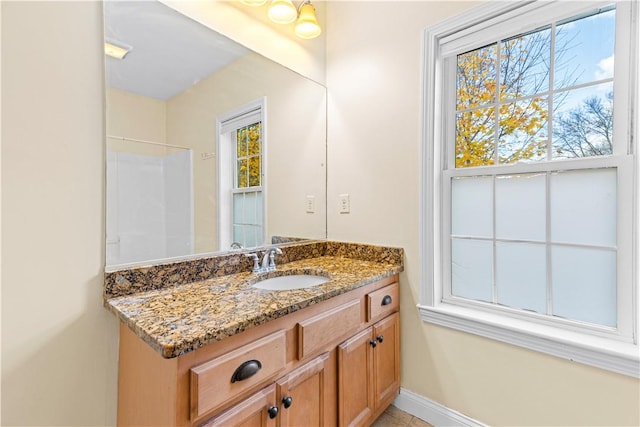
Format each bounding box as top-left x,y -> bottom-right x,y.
216,97 -> 267,250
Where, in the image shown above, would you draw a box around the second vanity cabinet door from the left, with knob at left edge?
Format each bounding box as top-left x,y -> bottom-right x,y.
276,353 -> 335,427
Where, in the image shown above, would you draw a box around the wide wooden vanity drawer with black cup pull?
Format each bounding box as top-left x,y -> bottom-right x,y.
191,331 -> 286,420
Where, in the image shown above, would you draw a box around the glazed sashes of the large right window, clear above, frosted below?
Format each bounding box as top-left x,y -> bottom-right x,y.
442,6 -> 629,333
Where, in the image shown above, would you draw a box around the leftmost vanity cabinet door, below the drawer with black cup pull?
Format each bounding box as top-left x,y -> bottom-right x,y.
202,384 -> 278,427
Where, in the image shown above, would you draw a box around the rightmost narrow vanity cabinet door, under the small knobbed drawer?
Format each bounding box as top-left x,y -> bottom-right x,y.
373,313 -> 400,410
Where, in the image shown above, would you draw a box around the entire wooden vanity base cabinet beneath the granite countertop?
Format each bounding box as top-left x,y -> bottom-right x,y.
118,276 -> 400,427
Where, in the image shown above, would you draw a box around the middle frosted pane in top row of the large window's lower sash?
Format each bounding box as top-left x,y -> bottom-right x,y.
495,174 -> 546,242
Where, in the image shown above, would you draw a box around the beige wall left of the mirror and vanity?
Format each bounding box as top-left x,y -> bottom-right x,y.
1,1 -> 118,426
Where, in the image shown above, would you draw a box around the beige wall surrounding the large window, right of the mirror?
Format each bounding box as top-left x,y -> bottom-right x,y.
327,1 -> 640,426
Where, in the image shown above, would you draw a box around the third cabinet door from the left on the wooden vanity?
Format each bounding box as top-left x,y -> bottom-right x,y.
338,327 -> 374,426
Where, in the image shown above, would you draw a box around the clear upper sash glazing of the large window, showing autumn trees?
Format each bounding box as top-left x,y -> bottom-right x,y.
452,6 -> 615,168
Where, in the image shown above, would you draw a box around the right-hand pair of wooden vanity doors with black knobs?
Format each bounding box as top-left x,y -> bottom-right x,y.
338,313 -> 400,426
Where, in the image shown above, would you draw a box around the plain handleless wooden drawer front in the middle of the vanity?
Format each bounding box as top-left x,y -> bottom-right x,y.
298,299 -> 362,360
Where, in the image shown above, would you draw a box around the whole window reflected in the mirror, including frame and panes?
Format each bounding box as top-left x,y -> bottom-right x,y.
218,100 -> 266,248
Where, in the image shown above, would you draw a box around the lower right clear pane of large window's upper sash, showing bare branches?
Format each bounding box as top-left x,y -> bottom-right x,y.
553,83 -> 613,159
